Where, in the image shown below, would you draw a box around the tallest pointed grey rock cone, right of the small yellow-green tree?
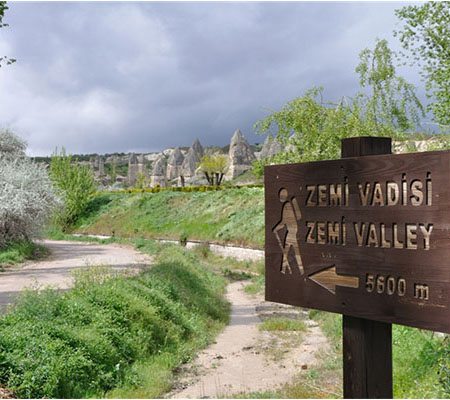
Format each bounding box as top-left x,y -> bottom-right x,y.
226,129 -> 255,180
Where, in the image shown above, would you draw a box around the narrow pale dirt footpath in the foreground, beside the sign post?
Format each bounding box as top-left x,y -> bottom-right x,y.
166,282 -> 328,398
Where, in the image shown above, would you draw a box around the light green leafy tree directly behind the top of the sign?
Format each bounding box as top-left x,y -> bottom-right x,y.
254,40 -> 423,167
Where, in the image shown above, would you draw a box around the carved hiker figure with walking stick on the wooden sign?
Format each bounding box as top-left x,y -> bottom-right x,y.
272,189 -> 304,275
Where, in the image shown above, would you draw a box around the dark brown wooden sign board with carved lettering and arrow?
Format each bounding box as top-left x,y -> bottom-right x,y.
265,151 -> 450,333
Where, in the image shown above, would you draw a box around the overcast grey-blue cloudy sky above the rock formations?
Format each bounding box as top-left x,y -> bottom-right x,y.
0,2 -> 423,155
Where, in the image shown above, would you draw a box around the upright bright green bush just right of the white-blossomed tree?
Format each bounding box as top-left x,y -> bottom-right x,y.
50,148 -> 95,230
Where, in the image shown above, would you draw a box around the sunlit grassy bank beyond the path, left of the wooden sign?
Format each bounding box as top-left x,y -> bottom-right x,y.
71,188 -> 264,247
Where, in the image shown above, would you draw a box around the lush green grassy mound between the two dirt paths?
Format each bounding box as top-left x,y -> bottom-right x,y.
0,241 -> 229,398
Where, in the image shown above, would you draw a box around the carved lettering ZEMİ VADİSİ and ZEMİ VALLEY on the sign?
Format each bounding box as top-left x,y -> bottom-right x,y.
305,172 -> 433,250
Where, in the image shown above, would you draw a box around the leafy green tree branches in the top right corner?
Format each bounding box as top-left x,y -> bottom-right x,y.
394,1 -> 450,127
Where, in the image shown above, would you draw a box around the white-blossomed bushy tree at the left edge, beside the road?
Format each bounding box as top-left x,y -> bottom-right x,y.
0,130 -> 57,248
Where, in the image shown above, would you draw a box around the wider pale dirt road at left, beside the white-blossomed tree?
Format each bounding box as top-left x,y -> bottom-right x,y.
0,240 -> 152,310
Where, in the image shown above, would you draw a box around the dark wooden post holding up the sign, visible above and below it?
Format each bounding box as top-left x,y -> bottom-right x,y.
341,137 -> 393,399
